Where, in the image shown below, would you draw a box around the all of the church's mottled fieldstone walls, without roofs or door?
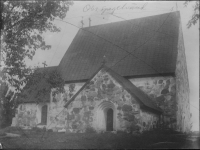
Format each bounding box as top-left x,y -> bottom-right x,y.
12,12 -> 190,132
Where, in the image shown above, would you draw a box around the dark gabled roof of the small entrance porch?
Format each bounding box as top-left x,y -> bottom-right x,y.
65,65 -> 162,113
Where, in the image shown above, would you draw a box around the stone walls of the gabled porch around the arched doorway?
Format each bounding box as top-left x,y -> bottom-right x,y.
58,70 -> 158,132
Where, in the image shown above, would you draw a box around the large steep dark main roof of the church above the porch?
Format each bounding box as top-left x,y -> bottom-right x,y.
58,12 -> 180,81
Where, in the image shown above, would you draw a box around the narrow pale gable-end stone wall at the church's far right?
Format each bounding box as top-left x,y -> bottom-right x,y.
176,17 -> 190,132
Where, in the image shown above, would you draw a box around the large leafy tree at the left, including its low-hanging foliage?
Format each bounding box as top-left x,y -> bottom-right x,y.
0,0 -> 73,127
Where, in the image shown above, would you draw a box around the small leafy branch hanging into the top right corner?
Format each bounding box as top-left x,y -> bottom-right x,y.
184,1 -> 199,28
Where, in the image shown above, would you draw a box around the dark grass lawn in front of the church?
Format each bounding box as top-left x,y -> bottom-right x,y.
0,126 -> 200,149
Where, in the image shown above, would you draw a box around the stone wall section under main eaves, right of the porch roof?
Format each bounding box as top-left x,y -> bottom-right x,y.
130,76 -> 178,129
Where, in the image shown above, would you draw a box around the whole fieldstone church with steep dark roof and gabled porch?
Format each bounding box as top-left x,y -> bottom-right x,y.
12,11 -> 190,133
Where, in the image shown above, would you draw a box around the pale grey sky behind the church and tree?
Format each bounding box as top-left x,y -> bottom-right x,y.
26,1 -> 199,131
